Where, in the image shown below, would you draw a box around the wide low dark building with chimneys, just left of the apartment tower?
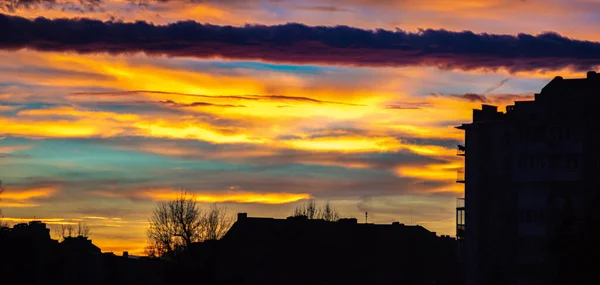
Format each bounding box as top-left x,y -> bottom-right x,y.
192,213 -> 460,285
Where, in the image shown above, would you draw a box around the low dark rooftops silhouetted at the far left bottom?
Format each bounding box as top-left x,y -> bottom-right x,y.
0,221 -> 169,285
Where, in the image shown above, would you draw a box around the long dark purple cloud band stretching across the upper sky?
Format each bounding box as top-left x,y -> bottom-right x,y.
0,15 -> 600,72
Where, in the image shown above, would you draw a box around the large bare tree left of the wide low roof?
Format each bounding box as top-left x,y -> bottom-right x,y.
146,190 -> 233,257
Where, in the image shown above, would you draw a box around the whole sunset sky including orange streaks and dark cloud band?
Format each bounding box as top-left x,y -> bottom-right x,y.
0,0 -> 600,254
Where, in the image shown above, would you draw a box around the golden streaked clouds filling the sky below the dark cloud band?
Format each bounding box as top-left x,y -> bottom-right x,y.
0,26 -> 568,253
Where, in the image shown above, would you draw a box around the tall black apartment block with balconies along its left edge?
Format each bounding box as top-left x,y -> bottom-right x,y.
456,71 -> 600,285
